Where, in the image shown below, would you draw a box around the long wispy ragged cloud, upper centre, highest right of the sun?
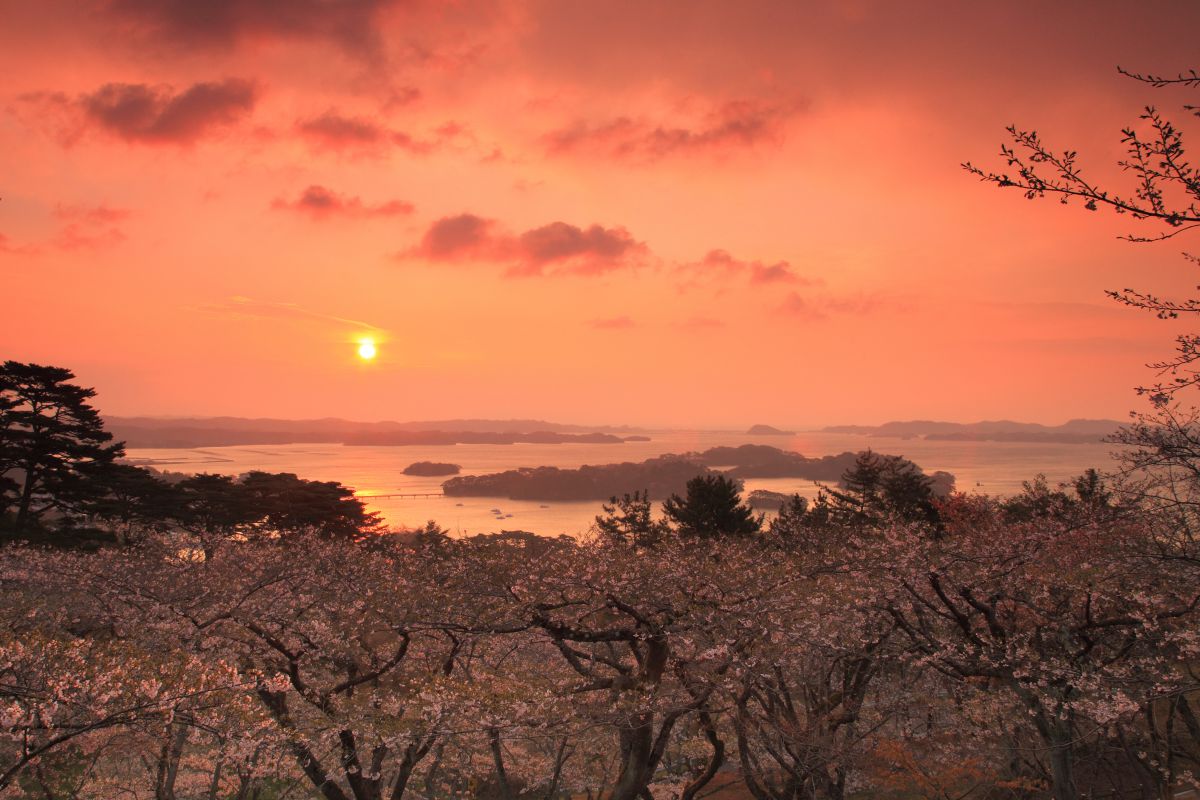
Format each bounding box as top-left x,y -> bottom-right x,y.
544,101 -> 799,161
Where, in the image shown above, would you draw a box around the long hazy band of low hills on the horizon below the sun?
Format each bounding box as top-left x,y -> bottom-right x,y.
104,416 -> 644,447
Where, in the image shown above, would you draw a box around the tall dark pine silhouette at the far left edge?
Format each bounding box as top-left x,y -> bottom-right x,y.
0,361 -> 124,534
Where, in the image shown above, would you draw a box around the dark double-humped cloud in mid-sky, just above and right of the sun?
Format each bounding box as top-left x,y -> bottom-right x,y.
404,213 -> 649,276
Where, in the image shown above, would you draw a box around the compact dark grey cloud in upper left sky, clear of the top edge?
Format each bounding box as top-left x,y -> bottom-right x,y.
77,78 -> 257,144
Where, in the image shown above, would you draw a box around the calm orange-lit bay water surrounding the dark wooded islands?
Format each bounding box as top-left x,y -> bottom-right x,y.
121,431 -> 1112,535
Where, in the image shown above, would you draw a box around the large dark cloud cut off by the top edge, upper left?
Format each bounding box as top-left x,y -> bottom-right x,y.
101,0 -> 400,55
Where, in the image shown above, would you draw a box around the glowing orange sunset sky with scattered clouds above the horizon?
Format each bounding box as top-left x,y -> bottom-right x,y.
0,0 -> 1200,426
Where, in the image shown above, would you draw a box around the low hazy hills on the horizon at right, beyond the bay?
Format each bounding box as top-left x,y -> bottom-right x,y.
821,420 -> 1124,444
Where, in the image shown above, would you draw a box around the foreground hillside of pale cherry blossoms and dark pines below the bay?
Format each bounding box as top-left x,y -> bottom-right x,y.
0,362 -> 1200,800
